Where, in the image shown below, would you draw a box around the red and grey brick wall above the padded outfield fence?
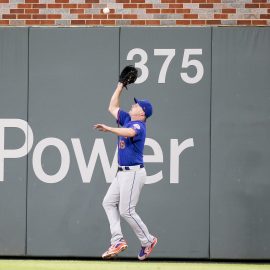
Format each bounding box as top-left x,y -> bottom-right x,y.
0,0 -> 270,26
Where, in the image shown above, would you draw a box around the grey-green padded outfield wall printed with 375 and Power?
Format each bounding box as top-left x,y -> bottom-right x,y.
0,27 -> 270,259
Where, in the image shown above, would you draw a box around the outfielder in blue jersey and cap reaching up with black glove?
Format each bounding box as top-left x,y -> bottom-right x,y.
94,66 -> 157,260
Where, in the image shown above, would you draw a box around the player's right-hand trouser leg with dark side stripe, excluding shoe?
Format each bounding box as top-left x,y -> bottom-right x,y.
118,168 -> 155,247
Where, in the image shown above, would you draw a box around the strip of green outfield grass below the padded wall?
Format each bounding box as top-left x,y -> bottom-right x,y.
0,260 -> 270,270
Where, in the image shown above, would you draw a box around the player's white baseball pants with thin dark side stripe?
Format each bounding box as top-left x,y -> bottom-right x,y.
102,168 -> 154,246
